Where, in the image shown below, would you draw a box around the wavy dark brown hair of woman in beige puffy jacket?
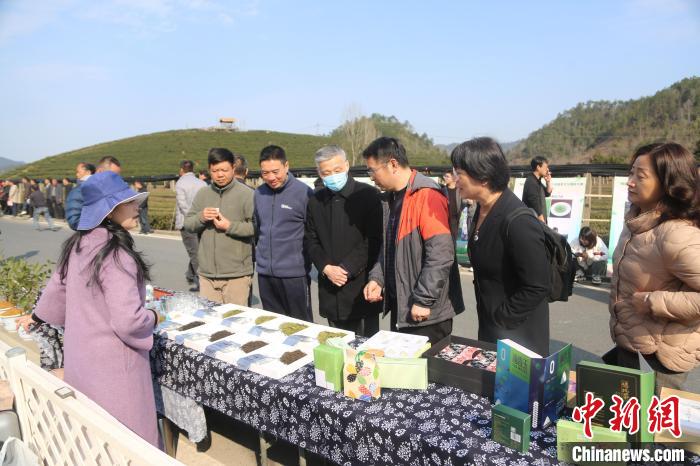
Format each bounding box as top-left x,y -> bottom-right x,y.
632,142 -> 700,227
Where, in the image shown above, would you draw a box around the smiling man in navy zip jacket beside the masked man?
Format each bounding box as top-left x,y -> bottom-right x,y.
254,146 -> 313,322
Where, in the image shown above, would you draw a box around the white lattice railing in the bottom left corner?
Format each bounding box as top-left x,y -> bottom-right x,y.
0,348 -> 182,466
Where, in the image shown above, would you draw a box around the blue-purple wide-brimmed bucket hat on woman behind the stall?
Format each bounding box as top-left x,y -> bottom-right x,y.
78,171 -> 148,230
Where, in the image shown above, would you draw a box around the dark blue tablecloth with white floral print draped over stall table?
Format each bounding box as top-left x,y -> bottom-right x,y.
151,338 -> 559,466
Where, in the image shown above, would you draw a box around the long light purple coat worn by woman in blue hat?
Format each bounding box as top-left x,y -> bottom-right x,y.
34,227 -> 159,446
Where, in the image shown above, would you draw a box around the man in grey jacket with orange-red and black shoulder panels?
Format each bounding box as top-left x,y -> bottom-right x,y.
362,137 -> 464,344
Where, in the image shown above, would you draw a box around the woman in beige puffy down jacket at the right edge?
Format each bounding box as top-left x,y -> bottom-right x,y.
610,143 -> 700,393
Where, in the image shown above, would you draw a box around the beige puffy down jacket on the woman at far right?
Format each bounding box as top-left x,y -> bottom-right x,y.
610,207 -> 700,372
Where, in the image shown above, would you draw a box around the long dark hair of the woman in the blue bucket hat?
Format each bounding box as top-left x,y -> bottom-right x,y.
58,219 -> 151,291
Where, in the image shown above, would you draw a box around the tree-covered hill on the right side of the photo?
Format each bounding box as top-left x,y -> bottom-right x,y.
508,77 -> 700,164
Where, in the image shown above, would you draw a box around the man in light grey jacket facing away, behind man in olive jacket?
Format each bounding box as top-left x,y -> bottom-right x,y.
175,160 -> 207,291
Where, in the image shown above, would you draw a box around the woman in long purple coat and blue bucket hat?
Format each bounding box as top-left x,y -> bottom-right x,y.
34,172 -> 159,446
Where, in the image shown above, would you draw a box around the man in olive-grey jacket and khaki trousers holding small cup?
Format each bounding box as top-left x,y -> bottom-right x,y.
185,148 -> 254,306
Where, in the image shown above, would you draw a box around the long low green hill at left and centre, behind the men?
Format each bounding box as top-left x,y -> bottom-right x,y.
2,115 -> 447,178
